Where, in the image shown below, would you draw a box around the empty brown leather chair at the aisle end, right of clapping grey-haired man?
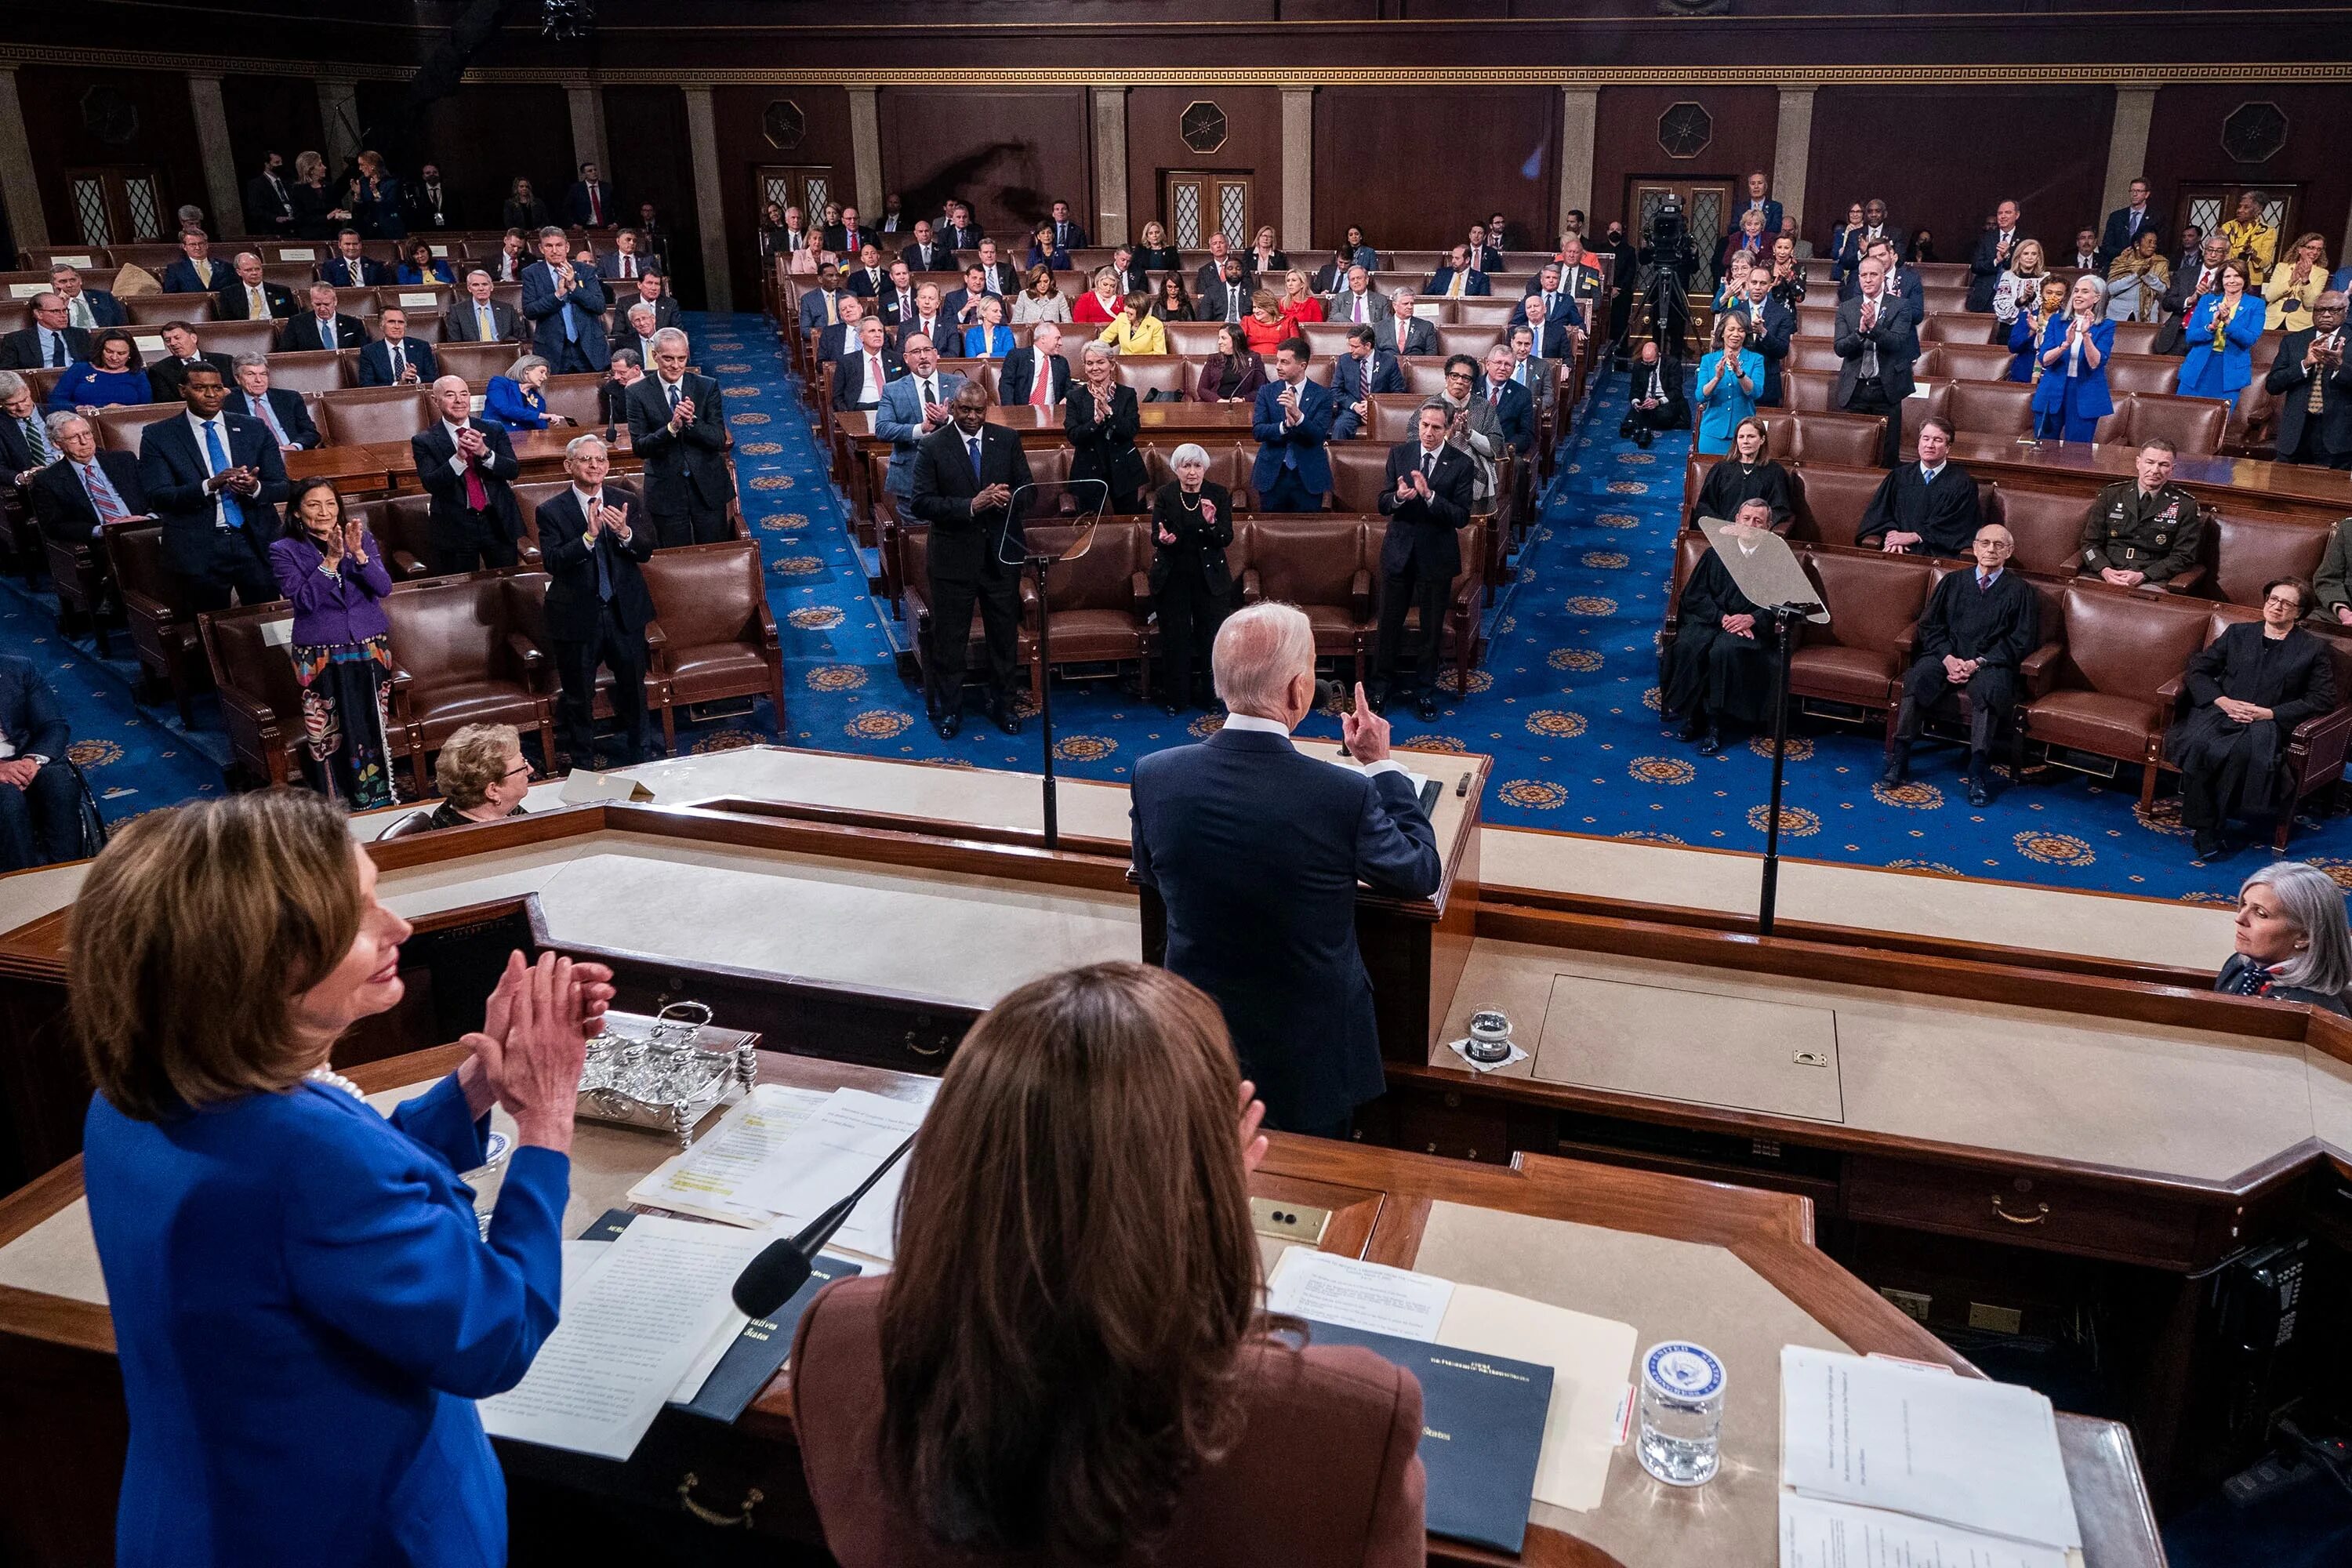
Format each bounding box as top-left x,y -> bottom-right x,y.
642,539 -> 781,753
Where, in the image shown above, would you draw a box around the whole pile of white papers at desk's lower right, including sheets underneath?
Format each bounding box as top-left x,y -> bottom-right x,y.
1780,1345 -> 2082,1568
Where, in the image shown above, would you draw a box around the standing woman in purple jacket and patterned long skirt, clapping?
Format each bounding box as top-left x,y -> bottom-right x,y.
270,477 -> 393,811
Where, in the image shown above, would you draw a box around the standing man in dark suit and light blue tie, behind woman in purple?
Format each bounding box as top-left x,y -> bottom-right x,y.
139,365 -> 287,609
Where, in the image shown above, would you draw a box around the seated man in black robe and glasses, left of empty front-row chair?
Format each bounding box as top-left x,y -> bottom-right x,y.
1879,522 -> 2039,806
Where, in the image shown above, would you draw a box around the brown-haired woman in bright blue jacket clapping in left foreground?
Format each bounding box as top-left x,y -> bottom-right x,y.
85,789 -> 612,1568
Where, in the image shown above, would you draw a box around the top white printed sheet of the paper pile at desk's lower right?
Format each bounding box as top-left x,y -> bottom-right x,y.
1780,1345 -> 2082,1561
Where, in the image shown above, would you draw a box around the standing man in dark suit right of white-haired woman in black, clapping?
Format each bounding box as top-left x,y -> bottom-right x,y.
1371,404 -> 1468,724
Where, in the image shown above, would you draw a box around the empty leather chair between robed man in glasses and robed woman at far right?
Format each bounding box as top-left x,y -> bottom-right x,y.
2018,583 -> 2211,808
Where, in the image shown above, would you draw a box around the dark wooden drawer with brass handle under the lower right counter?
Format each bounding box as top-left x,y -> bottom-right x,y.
1844,1156 -> 2227,1269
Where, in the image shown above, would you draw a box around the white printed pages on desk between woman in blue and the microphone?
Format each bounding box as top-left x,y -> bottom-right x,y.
480,1215 -> 771,1460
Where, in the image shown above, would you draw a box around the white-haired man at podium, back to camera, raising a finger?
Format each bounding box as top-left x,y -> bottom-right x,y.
1129,604 -> 1444,1138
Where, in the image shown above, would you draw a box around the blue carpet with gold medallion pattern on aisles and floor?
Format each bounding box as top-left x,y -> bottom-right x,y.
0,315 -> 2352,900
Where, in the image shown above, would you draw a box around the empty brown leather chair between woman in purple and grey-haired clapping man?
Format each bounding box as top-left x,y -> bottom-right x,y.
383,572 -> 555,794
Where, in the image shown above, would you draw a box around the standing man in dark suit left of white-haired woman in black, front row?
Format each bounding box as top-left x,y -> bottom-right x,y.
908,381 -> 1030,741
